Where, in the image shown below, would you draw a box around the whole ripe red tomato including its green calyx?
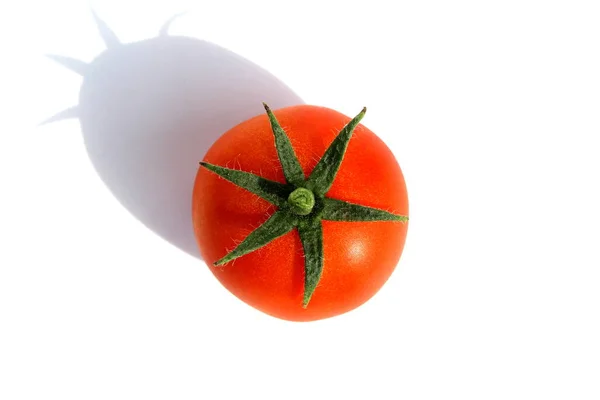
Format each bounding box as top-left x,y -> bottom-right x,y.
192,105 -> 408,321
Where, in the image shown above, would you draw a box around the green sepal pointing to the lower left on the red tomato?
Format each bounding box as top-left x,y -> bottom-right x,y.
214,211 -> 298,266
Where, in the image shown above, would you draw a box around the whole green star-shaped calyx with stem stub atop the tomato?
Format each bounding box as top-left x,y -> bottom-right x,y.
200,103 -> 408,308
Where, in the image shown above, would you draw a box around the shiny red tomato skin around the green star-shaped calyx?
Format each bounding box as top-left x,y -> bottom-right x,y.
192,105 -> 408,321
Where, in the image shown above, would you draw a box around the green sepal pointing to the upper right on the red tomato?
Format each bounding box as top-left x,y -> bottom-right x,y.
306,107 -> 367,196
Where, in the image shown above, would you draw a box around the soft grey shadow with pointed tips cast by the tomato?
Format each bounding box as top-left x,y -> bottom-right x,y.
45,14 -> 303,258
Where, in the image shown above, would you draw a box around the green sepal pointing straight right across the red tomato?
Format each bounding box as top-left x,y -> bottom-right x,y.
321,198 -> 408,222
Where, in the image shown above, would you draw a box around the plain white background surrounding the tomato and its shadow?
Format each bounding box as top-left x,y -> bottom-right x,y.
0,0 -> 600,400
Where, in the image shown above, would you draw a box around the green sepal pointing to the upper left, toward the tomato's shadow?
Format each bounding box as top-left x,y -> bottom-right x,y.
200,162 -> 294,207
